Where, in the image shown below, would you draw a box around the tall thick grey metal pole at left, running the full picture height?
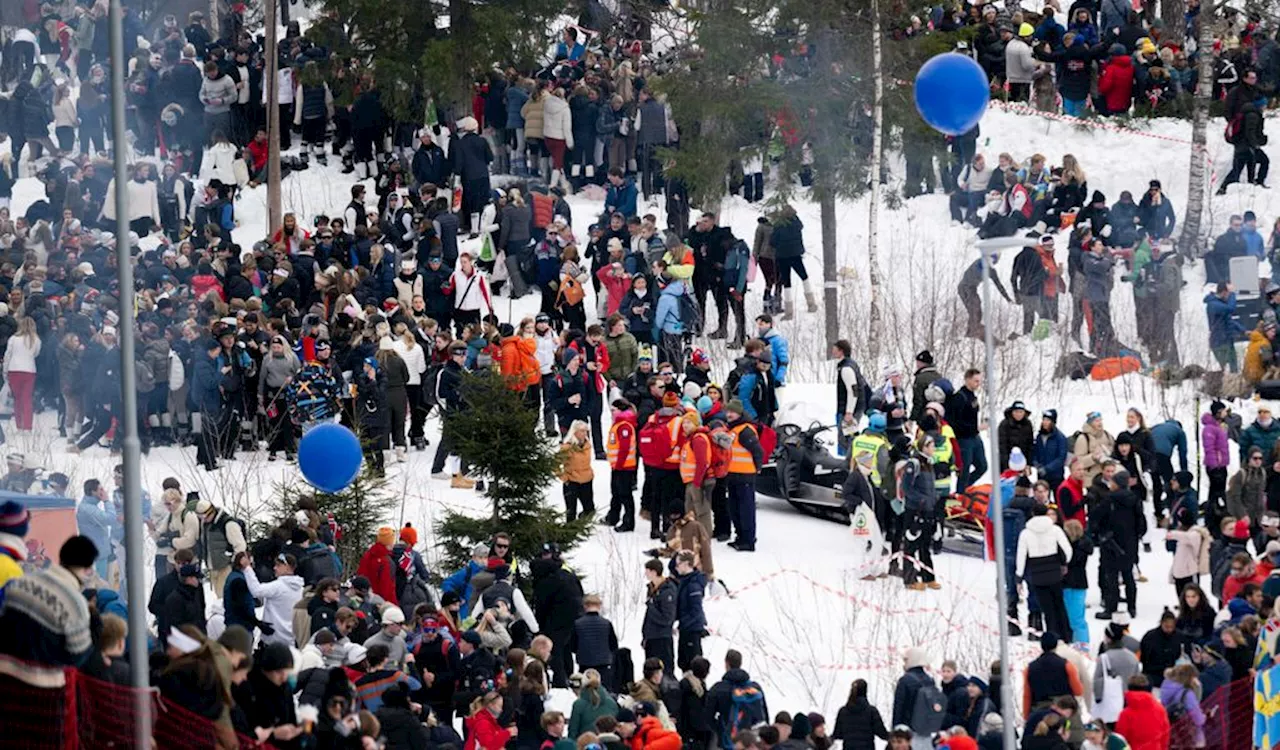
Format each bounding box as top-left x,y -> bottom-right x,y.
108,0 -> 149,747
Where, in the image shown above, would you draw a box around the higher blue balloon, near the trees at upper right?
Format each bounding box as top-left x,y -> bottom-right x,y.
915,52 -> 991,136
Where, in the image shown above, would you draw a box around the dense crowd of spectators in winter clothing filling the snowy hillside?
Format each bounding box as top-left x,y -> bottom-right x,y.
0,0 -> 1280,750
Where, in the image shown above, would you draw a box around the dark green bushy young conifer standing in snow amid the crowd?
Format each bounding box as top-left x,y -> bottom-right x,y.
435,375 -> 591,581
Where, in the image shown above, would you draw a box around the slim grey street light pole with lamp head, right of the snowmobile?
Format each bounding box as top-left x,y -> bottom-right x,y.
960,237 -> 1036,750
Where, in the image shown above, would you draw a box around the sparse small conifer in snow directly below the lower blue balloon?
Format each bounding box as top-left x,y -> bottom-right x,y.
251,463 -> 399,576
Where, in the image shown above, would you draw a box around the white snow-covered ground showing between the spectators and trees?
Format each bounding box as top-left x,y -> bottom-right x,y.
6,100 -> 1280,719
